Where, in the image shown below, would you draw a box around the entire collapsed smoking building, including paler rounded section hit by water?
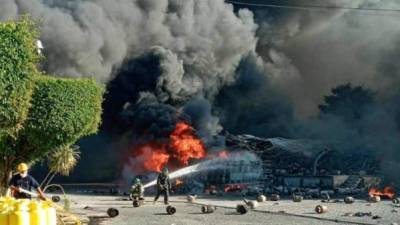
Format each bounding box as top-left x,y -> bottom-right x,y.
198,134 -> 381,194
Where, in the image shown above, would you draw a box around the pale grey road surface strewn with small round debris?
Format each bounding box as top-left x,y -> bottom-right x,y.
57,195 -> 400,225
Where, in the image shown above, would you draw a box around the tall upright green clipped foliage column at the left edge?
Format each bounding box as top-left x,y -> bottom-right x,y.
0,19 -> 40,139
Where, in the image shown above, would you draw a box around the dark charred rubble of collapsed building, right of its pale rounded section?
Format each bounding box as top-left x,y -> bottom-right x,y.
226,134 -> 381,193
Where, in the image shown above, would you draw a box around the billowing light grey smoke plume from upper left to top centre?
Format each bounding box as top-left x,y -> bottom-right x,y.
0,0 -> 257,101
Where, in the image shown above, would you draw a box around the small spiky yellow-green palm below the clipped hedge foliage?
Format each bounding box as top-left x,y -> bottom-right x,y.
41,145 -> 80,188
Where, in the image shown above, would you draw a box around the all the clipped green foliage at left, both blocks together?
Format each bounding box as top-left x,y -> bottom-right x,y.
0,18 -> 104,191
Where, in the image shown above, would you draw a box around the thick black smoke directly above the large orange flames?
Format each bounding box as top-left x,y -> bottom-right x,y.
103,47 -> 222,142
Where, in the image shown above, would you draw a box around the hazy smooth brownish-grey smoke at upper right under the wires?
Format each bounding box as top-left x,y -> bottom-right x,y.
254,0 -> 400,118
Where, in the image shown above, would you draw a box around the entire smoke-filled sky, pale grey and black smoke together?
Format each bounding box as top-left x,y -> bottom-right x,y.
0,0 -> 400,183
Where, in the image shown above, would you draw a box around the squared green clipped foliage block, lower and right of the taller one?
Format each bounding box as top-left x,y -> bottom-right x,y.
22,76 -> 103,158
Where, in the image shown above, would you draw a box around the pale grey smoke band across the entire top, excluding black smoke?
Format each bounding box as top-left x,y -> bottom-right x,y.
0,0 -> 400,117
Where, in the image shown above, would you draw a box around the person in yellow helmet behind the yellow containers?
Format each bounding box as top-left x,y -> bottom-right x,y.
10,163 -> 46,200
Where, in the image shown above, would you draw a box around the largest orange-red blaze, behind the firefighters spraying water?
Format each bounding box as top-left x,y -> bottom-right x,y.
131,122 -> 207,172
